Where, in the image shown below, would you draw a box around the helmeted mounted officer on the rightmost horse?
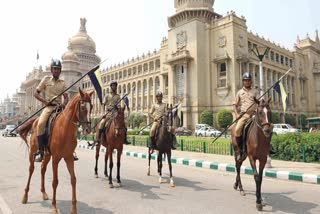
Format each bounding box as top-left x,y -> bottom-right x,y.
233,72 -> 259,160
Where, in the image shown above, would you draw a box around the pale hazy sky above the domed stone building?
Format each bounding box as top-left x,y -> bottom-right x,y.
0,0 -> 320,102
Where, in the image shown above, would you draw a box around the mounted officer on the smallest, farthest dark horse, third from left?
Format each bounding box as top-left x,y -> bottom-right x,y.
149,91 -> 176,150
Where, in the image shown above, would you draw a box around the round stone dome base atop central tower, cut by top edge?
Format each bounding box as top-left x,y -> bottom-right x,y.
174,0 -> 214,13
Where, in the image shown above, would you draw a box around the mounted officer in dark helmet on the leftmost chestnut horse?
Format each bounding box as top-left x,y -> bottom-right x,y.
34,60 -> 69,162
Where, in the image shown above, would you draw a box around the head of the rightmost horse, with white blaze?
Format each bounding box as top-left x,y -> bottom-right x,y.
256,98 -> 273,138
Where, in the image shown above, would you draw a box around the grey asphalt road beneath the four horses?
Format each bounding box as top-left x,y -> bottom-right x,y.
0,136 -> 320,214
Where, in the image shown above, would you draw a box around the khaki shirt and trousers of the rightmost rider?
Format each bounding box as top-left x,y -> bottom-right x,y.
233,87 -> 259,137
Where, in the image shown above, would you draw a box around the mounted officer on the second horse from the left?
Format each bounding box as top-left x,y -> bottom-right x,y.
96,80 -> 131,145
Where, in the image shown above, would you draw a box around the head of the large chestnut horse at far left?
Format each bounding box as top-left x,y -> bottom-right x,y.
77,88 -> 93,135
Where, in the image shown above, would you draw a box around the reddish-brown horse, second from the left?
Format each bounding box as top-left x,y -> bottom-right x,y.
94,107 -> 126,188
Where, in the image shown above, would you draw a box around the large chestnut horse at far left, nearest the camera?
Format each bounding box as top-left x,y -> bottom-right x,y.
18,89 -> 93,214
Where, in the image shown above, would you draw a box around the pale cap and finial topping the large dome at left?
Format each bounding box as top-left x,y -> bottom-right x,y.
68,18 -> 96,52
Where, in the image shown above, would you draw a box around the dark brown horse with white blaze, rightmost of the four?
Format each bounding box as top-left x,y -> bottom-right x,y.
231,98 -> 273,211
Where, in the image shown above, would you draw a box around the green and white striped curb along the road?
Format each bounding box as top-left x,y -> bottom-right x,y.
77,144 -> 320,184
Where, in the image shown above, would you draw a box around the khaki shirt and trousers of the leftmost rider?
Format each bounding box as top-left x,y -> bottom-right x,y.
36,76 -> 67,136
